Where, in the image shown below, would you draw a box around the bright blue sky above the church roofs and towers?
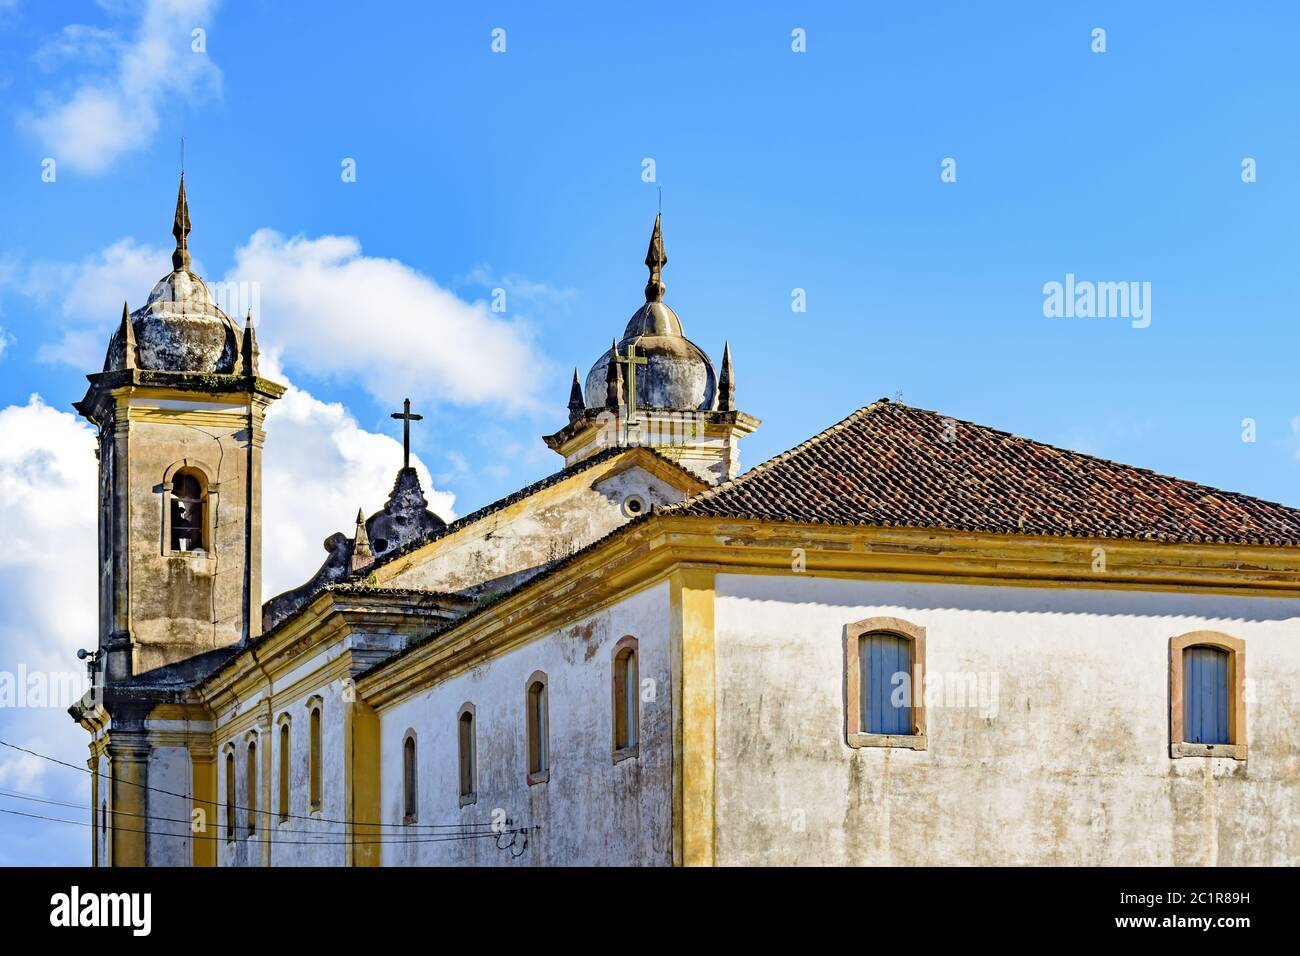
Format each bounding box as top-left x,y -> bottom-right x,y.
0,0 -> 1300,862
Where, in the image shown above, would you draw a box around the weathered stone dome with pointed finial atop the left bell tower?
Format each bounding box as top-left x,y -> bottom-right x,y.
104,177 -> 239,375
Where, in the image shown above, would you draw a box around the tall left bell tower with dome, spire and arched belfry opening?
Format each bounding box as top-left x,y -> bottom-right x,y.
75,174 -> 283,687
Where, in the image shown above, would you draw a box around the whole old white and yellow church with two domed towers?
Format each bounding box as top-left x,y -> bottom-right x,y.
72,179 -> 1300,866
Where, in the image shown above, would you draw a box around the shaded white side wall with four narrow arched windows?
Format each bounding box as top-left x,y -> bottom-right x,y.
380,584 -> 672,866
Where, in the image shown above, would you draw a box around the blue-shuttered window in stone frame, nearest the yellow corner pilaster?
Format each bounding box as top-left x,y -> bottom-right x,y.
844,618 -> 927,750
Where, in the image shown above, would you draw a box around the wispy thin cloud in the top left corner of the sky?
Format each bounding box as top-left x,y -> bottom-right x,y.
20,0 -> 221,173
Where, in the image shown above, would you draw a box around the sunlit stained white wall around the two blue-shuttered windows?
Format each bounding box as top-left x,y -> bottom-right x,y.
716,575 -> 1300,866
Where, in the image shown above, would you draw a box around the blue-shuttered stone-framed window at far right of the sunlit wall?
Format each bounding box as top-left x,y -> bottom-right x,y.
1169,631 -> 1245,760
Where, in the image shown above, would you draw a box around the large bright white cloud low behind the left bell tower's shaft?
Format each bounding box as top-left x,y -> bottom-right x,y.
0,377 -> 452,865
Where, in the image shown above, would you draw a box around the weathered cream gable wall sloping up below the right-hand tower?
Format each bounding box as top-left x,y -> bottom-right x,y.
384,467 -> 684,596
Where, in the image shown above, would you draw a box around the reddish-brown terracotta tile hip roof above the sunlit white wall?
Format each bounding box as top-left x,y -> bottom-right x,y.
659,399 -> 1300,546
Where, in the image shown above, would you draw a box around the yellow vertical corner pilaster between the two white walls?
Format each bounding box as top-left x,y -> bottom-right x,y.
668,568 -> 718,866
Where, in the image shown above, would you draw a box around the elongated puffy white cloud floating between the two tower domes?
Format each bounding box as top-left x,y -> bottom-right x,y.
226,229 -> 545,410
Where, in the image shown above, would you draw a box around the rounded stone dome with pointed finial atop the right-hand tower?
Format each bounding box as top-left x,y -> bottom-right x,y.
584,217 -> 718,411
